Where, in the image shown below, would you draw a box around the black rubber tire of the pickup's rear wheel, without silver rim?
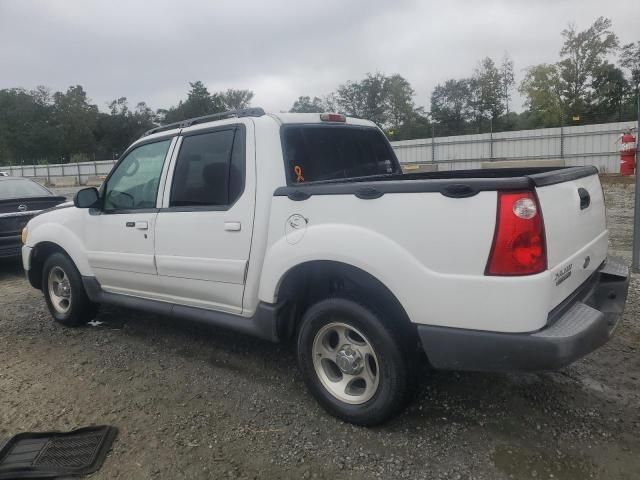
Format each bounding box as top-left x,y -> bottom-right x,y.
297,298 -> 413,426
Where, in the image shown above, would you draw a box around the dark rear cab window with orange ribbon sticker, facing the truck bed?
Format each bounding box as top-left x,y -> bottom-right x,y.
283,125 -> 401,183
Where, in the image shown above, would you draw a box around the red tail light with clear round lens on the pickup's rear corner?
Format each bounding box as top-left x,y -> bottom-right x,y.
485,191 -> 547,275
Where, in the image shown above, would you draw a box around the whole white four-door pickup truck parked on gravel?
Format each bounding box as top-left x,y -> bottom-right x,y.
22,109 -> 629,425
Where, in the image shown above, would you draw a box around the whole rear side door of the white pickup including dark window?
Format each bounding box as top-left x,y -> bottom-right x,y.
156,120 -> 255,313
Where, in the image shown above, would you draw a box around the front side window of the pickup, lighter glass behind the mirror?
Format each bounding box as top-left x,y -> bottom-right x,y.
104,139 -> 171,210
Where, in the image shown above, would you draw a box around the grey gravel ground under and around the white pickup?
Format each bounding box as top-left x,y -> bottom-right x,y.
0,184 -> 640,480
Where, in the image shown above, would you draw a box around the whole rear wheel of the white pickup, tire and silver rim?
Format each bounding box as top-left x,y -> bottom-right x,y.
297,298 -> 413,426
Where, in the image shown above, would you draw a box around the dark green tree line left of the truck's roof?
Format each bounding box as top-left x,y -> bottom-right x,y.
0,82 -> 253,165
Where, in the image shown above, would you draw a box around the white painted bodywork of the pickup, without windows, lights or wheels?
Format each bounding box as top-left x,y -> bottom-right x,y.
23,114 -> 608,338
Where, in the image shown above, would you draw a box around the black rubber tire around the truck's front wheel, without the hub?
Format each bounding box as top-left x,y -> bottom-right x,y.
42,252 -> 97,327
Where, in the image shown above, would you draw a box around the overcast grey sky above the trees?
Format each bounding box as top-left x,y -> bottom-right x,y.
0,0 -> 640,111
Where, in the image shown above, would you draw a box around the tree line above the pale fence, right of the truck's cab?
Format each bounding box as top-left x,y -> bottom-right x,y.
290,17 -> 640,140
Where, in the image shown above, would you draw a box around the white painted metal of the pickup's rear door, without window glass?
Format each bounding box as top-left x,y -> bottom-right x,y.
155,119 -> 256,314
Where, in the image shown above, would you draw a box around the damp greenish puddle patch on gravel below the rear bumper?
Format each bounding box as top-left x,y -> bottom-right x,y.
491,445 -> 595,480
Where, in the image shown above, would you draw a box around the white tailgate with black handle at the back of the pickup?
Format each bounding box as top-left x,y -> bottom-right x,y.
536,173 -> 609,310
